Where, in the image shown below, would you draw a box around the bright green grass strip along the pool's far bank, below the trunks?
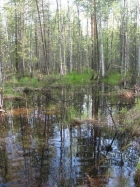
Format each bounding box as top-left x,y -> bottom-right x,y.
4,70 -> 129,94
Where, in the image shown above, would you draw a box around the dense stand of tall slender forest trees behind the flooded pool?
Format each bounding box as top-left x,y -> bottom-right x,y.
0,0 -> 140,83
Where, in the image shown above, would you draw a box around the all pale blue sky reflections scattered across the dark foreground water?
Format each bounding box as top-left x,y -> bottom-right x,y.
1,107 -> 137,187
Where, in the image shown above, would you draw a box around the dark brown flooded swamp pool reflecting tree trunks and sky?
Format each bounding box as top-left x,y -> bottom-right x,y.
0,88 -> 139,187
